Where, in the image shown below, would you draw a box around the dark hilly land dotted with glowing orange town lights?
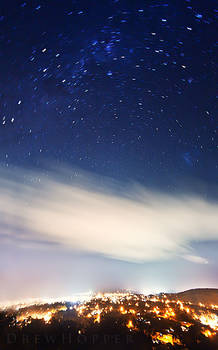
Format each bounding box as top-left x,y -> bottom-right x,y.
0,289 -> 218,350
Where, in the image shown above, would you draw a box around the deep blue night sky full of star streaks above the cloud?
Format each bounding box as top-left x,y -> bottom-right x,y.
0,0 -> 218,300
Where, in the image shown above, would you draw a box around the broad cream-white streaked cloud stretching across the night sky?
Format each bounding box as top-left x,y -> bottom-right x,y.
0,170 -> 218,264
